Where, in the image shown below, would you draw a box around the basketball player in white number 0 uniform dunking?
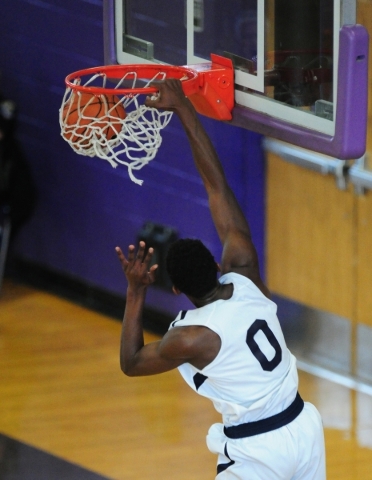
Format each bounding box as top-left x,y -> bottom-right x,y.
116,79 -> 325,480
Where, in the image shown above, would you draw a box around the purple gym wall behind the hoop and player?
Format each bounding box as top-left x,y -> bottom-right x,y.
0,0 -> 264,314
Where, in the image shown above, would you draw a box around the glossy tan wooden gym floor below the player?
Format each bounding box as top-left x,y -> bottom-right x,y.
0,280 -> 372,480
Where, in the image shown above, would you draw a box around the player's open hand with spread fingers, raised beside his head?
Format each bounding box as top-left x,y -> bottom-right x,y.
115,241 -> 158,290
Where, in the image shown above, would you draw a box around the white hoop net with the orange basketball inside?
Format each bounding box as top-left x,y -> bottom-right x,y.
59,72 -> 172,185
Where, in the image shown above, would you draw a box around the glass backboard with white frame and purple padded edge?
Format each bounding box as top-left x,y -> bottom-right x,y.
104,0 -> 368,159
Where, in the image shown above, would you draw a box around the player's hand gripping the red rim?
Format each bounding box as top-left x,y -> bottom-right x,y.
145,78 -> 188,111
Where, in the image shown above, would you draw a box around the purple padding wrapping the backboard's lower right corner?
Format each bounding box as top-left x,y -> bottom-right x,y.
231,25 -> 369,160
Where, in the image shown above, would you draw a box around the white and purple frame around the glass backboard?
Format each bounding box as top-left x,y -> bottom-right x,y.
104,0 -> 368,159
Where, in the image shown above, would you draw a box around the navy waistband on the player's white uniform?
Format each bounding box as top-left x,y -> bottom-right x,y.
223,392 -> 304,438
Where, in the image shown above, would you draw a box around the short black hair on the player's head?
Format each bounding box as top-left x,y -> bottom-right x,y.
166,238 -> 217,298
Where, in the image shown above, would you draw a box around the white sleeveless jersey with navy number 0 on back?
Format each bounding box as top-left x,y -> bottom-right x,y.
169,272 -> 298,426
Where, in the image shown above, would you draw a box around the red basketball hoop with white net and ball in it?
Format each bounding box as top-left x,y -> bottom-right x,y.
59,56 -> 234,185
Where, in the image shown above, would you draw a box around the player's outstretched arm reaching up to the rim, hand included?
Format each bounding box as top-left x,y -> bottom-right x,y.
146,79 -> 269,295
